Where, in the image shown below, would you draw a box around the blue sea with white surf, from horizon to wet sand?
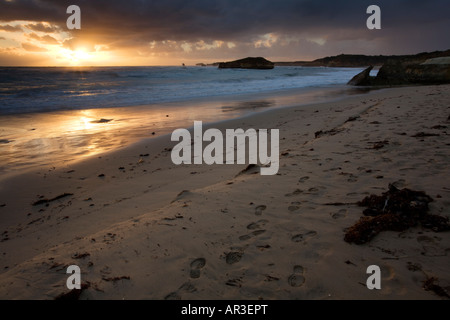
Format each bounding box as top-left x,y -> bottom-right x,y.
0,67 -> 366,115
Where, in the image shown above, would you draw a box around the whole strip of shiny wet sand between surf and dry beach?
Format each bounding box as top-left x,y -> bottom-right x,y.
0,86 -> 378,180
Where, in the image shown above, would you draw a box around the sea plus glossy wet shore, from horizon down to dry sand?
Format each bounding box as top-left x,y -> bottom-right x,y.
0,67 -> 372,178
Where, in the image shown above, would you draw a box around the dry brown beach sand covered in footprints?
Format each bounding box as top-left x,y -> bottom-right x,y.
0,86 -> 450,299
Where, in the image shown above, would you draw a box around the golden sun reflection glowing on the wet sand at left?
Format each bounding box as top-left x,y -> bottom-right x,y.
0,100 -> 253,174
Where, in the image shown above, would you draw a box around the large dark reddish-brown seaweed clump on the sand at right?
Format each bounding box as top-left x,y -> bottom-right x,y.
344,184 -> 450,244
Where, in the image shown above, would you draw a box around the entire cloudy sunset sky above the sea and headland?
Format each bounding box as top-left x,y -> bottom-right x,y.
0,0 -> 450,66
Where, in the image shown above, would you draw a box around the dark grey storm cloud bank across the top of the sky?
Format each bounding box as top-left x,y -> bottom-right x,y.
0,0 -> 450,53
